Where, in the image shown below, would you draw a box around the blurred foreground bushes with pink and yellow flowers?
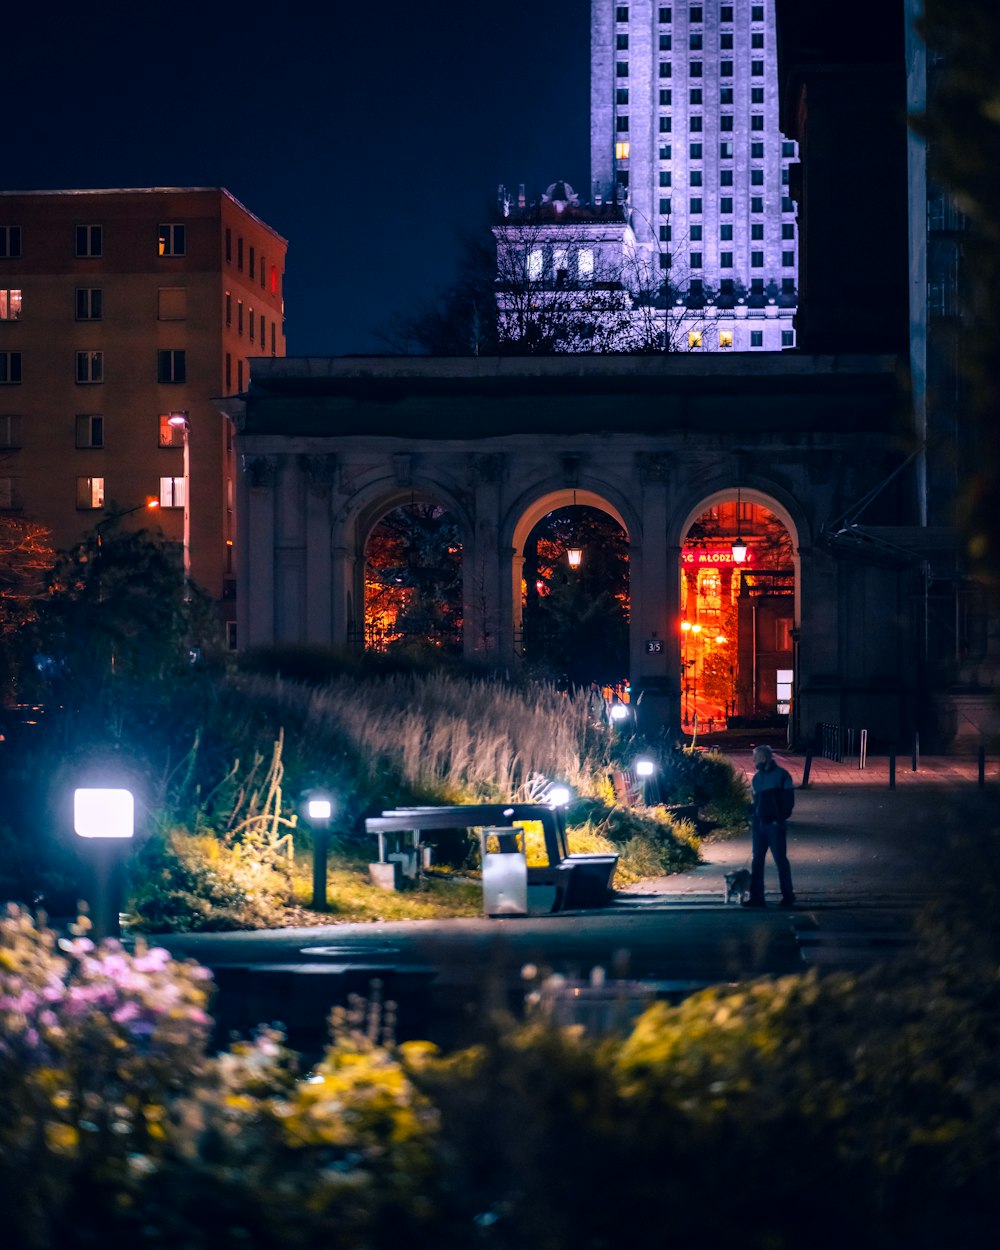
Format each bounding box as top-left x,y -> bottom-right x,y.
0,831 -> 1000,1250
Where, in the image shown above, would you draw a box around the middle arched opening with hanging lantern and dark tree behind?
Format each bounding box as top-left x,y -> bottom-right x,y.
515,490 -> 630,690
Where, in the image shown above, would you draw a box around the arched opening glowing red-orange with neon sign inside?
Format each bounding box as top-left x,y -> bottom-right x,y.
680,489 -> 799,731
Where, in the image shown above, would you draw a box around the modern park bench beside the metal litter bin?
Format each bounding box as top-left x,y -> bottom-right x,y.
365,803 -> 619,911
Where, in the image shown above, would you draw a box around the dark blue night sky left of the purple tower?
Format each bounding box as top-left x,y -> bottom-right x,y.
7,0 -> 590,355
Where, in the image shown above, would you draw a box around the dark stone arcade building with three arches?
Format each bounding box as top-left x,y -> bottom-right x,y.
226,354 -> 930,741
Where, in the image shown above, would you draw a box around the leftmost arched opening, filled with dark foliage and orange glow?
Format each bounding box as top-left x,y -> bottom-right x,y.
364,495 -> 464,655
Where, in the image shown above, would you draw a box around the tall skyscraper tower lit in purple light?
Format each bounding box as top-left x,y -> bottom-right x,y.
590,0 -> 798,351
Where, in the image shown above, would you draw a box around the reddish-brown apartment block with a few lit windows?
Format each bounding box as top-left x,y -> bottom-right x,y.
0,188 -> 288,635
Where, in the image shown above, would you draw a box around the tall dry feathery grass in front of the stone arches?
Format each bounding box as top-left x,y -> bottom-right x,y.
239,674 -> 613,801
